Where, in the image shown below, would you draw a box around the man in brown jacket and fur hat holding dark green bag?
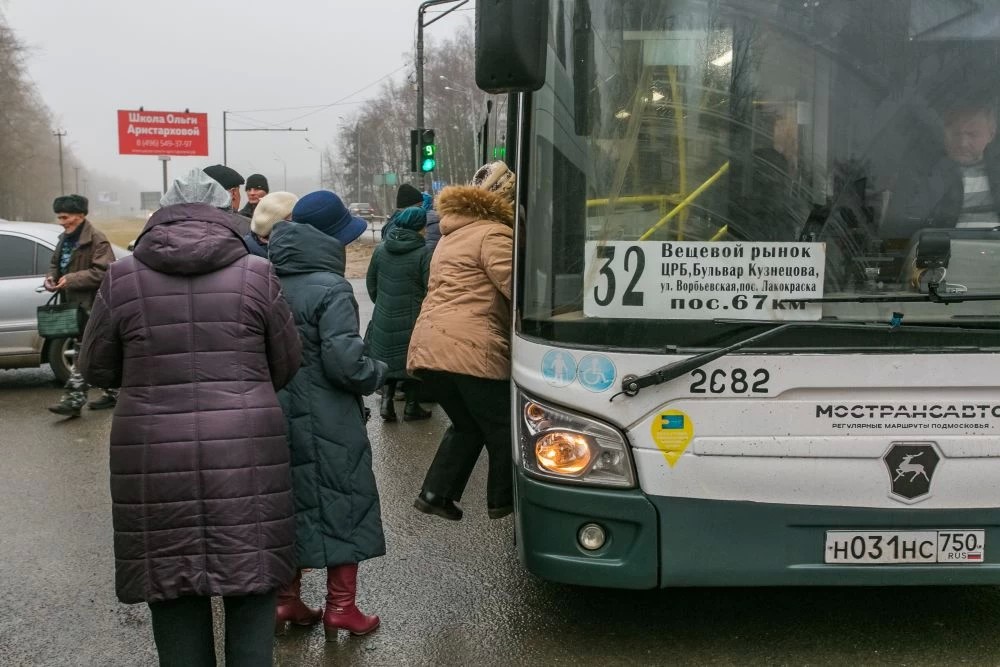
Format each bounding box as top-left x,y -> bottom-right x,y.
45,195 -> 118,417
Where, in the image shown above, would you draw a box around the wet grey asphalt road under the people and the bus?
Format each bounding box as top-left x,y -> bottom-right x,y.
0,280 -> 1000,666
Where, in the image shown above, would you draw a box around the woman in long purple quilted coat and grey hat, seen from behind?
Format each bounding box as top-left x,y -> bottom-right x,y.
80,169 -> 302,666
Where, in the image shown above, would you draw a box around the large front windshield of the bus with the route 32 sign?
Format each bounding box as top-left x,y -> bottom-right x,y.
517,0 -> 1000,349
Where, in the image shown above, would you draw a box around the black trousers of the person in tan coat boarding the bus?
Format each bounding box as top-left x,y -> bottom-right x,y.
420,371 -> 514,507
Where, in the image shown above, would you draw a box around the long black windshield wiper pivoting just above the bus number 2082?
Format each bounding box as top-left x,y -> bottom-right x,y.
611,320 -> 1000,400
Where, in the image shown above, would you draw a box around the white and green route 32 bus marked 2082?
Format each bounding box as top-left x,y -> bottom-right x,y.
476,0 -> 1000,589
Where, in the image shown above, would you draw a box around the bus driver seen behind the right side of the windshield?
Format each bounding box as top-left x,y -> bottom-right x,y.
881,95 -> 1000,239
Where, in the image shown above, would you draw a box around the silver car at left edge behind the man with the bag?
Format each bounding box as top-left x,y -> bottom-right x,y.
0,220 -> 129,383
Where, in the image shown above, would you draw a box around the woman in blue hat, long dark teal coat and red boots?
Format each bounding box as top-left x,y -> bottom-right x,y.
268,191 -> 386,641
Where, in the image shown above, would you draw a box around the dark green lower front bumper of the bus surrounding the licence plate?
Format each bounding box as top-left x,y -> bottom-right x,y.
516,471 -> 1000,589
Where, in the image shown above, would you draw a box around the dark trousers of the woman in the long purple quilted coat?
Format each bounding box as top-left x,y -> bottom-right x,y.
149,592 -> 278,667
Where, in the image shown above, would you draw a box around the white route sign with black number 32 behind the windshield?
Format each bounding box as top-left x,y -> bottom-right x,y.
583,241 -> 826,321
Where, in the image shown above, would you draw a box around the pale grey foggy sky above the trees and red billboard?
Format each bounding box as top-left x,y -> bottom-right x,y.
0,0 -> 474,201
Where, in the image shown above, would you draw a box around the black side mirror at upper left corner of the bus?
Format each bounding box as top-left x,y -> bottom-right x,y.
476,0 -> 549,94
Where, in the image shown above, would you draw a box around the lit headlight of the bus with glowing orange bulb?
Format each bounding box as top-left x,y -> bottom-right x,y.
518,392 -> 635,488
